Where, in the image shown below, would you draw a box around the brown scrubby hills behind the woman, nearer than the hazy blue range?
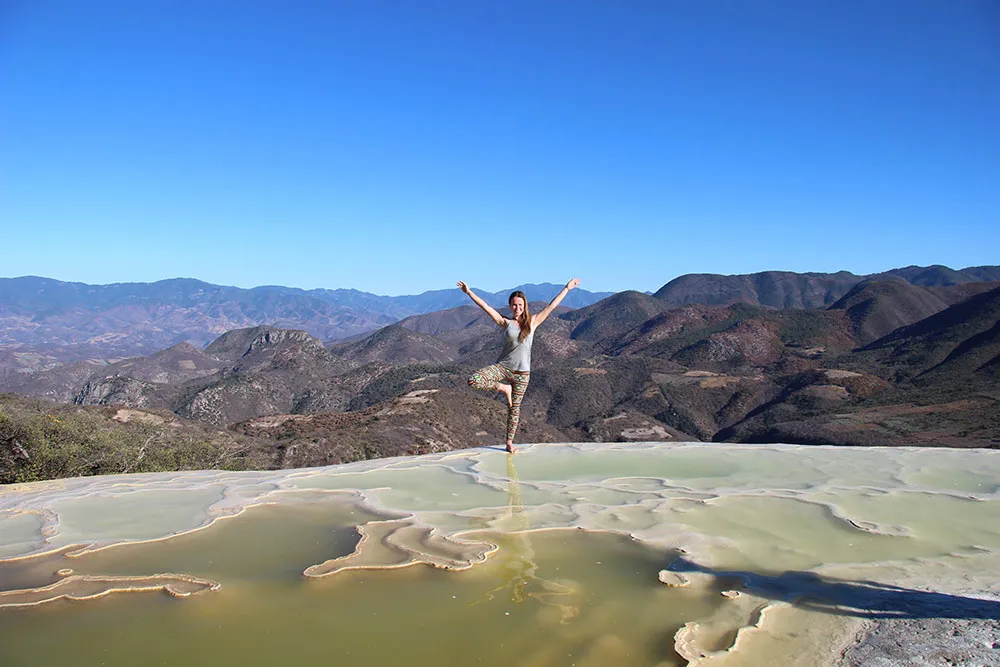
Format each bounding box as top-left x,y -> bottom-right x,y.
0,267 -> 1000,482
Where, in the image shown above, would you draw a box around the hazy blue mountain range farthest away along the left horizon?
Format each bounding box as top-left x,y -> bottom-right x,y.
0,276 -> 611,363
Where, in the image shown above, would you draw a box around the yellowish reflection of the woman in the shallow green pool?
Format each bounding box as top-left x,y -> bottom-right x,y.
475,454 -> 580,623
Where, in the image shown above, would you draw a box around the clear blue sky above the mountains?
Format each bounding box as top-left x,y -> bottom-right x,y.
0,0 -> 1000,295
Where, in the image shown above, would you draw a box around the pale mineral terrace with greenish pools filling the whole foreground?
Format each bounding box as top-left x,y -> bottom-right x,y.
0,444 -> 1000,667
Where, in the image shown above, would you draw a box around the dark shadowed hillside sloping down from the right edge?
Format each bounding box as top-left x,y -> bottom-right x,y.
714,287 -> 1000,447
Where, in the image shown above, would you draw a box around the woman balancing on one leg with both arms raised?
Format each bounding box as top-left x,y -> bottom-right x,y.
458,278 -> 580,454
